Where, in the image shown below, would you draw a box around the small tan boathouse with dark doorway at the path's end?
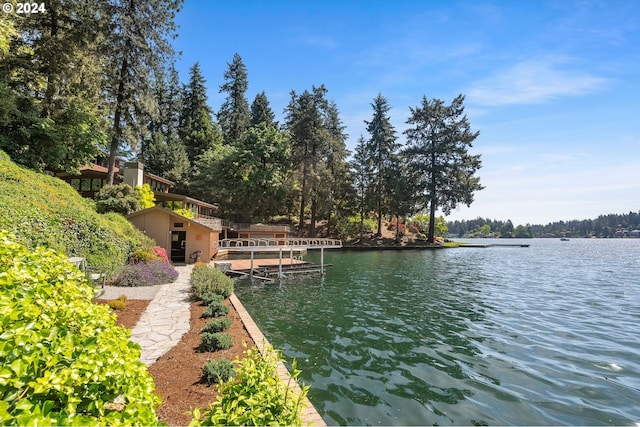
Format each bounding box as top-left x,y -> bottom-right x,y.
127,206 -> 222,263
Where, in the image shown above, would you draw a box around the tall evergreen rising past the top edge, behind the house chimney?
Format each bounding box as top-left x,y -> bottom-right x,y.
105,0 -> 182,184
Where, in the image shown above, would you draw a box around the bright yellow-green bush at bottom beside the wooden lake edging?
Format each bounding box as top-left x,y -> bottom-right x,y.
191,346 -> 309,426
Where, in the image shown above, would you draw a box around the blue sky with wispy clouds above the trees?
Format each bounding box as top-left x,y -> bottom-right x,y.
174,0 -> 640,225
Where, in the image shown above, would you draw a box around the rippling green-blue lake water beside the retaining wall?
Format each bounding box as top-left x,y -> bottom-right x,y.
236,239 -> 640,425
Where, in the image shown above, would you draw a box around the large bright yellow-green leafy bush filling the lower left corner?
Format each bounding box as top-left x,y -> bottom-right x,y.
0,232 -> 160,425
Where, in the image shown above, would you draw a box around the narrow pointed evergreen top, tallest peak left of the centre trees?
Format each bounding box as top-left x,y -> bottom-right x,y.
218,53 -> 251,144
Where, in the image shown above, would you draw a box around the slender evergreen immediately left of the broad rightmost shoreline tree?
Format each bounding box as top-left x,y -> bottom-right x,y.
365,94 -> 400,236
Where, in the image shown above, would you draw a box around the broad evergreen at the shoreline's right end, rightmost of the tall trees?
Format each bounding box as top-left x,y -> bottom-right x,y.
404,95 -> 483,243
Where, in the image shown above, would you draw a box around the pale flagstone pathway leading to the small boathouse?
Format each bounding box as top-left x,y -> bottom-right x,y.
131,265 -> 193,366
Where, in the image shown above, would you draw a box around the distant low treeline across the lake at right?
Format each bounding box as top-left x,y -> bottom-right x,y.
447,211 -> 640,237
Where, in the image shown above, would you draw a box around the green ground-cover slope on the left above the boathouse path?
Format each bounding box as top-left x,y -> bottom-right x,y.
0,151 -> 154,267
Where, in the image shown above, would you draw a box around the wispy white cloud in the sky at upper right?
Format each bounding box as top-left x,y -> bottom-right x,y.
466,56 -> 607,106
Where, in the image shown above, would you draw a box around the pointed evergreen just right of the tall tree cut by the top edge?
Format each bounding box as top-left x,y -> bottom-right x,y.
179,62 -> 222,169
